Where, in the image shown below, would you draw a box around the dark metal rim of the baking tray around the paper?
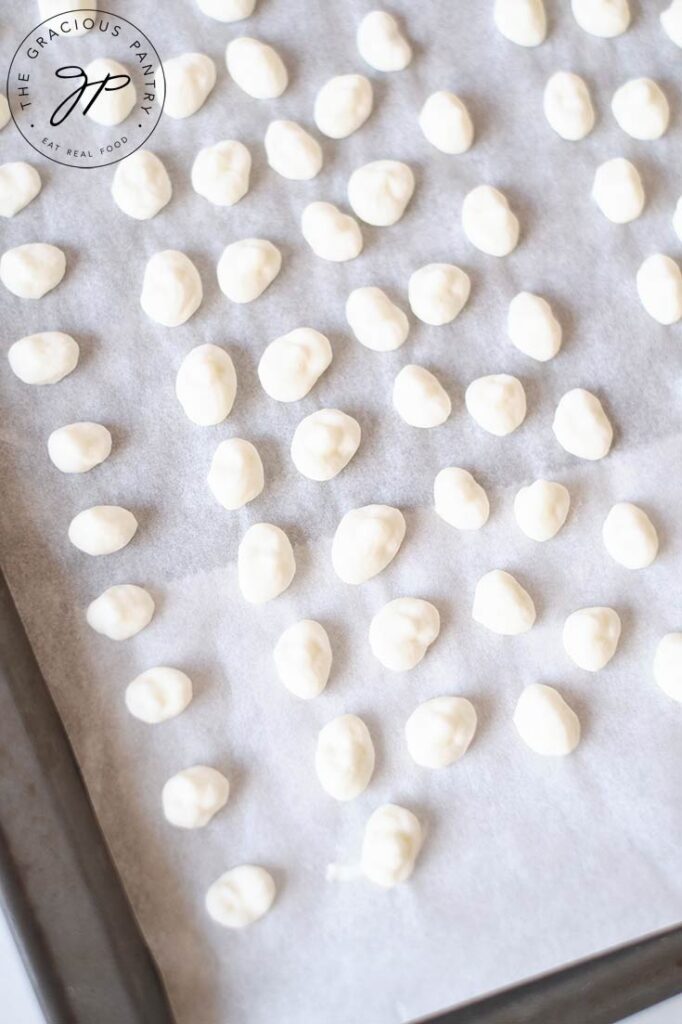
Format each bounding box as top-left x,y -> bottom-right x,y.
0,572 -> 682,1024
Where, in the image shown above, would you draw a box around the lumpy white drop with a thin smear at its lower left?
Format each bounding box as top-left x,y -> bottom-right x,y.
361,804 -> 423,889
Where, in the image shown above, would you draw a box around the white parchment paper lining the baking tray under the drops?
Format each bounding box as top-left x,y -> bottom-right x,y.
0,0 -> 682,1024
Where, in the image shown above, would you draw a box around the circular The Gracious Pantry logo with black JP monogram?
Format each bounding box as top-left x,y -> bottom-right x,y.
7,8 -> 166,168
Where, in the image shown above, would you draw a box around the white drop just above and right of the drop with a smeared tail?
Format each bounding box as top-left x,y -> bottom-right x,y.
404,697 -> 477,768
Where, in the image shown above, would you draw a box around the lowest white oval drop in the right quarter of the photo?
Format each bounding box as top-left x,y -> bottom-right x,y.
514,683 -> 581,757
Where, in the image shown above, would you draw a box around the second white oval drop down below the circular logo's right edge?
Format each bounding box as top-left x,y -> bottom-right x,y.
139,249 -> 204,327
